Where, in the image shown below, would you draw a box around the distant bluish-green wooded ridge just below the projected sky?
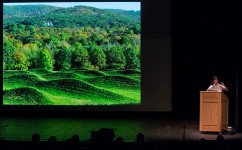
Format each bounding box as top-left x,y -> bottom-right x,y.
3,5 -> 141,28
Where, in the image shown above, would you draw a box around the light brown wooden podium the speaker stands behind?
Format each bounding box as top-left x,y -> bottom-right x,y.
199,91 -> 229,132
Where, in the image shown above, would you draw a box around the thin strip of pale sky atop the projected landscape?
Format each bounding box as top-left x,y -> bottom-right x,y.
4,2 -> 141,10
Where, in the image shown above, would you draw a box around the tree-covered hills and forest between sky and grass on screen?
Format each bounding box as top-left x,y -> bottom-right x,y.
3,5 -> 141,70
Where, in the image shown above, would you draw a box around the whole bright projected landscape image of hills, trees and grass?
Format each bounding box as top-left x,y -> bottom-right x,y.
2,2 -> 141,106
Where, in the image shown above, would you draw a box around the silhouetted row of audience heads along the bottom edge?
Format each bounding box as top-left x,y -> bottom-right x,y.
0,128 -> 242,150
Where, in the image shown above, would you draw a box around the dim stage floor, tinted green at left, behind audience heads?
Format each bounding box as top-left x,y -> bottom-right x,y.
0,117 -> 242,142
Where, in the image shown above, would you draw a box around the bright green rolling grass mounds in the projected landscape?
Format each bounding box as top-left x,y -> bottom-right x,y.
3,69 -> 141,105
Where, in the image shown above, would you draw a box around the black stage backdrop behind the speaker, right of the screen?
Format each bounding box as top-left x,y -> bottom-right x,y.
172,0 -> 242,131
